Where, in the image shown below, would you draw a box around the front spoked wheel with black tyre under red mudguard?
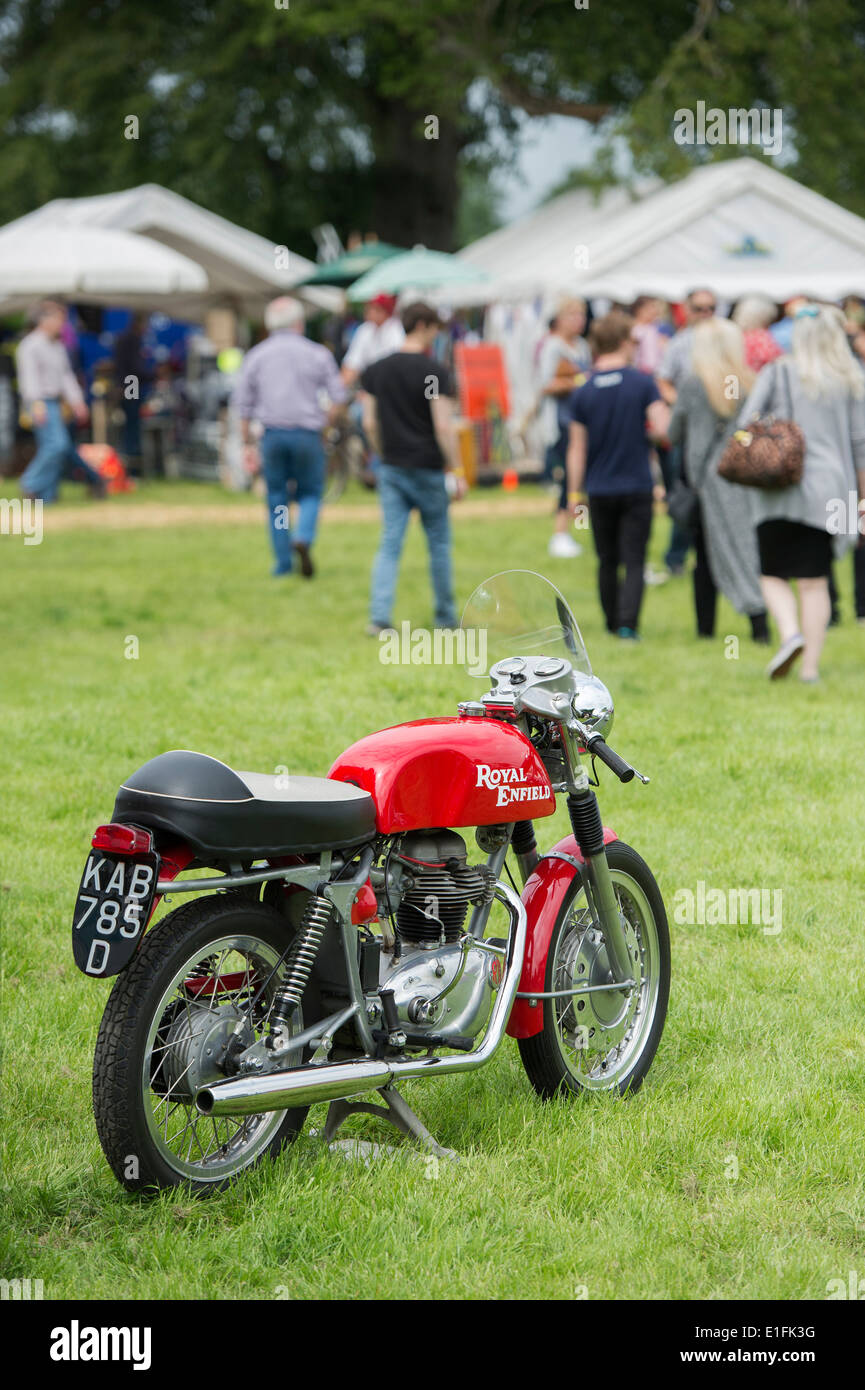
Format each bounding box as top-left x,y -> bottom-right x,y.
519,840 -> 670,1099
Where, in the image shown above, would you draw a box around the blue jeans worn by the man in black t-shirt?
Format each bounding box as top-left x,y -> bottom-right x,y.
370,463 -> 458,627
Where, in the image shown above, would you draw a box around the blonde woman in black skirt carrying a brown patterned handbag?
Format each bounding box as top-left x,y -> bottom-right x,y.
740,304 -> 865,682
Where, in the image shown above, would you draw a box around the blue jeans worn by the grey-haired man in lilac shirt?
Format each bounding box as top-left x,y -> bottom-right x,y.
261,430 -> 324,574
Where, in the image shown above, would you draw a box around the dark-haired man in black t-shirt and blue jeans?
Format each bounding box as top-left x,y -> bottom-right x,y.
360,303 -> 464,637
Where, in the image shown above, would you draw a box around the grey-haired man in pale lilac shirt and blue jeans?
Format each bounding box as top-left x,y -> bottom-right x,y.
231,296 -> 348,580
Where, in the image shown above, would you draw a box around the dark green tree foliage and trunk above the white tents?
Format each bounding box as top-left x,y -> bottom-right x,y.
0,0 -> 865,253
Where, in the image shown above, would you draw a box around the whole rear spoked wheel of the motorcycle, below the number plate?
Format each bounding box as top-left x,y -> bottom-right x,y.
93,894 -> 307,1191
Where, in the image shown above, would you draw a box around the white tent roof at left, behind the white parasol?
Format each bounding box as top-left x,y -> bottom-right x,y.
0,183 -> 342,321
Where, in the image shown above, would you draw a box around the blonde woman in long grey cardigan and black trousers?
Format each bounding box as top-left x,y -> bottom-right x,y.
670,318 -> 769,642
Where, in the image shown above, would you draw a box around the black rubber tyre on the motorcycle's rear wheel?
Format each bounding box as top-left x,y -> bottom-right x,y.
93,892 -> 309,1193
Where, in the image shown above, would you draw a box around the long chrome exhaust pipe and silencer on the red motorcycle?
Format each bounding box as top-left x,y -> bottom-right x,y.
196,883 -> 527,1115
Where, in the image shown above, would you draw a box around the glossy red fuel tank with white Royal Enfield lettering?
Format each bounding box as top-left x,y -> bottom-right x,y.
328,719 -> 556,835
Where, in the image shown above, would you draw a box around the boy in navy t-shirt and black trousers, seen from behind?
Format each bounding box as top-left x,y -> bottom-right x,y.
567,310 -> 669,639
